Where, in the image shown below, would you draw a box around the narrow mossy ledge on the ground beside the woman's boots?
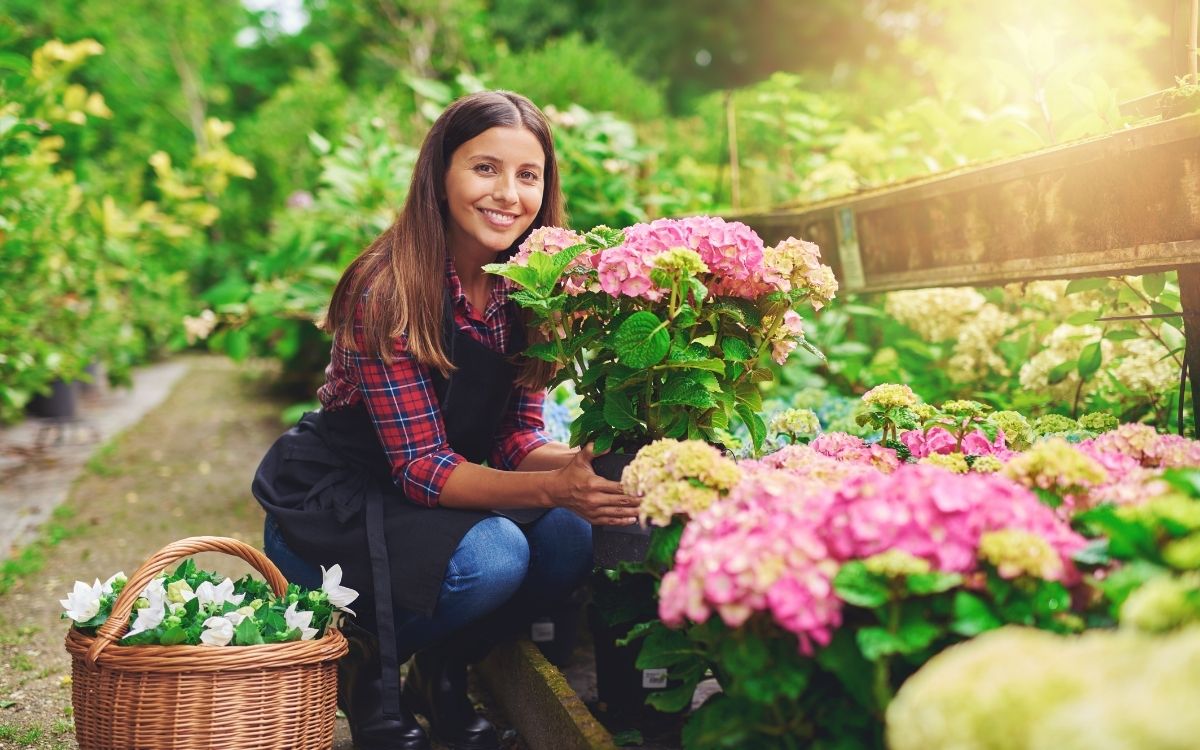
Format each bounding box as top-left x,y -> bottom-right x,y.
478,640 -> 617,750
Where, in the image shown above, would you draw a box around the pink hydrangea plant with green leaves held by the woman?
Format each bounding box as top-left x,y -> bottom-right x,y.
485,216 -> 838,564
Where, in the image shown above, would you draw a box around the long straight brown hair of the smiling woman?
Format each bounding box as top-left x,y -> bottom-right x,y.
320,91 -> 566,386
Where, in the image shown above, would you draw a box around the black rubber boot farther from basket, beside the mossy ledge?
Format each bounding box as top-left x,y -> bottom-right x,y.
404,642 -> 500,750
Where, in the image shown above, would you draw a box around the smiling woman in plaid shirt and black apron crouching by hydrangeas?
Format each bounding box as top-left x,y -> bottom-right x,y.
253,91 -> 637,750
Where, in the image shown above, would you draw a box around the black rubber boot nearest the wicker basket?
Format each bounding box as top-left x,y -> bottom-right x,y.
337,623 -> 431,750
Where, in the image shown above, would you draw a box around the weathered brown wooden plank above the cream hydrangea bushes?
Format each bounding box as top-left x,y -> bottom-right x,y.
737,114 -> 1200,292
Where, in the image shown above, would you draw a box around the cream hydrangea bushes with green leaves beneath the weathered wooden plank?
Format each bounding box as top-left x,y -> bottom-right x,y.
781,272 -> 1189,433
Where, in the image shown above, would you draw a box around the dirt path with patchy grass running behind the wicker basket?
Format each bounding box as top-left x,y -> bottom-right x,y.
0,356 -> 526,750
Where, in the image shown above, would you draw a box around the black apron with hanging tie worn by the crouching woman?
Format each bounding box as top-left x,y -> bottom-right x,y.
252,291 -> 546,707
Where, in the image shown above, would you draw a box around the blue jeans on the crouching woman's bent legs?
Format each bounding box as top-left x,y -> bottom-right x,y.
263,508 -> 592,660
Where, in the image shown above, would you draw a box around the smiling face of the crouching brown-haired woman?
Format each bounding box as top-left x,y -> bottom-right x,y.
445,127 -> 546,262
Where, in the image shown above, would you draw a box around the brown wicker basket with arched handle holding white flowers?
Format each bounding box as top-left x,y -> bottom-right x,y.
66,536 -> 347,750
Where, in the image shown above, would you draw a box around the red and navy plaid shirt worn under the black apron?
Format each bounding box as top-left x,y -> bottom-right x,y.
317,262 -> 551,508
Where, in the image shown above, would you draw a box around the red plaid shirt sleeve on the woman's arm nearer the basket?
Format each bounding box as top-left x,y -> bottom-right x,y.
350,316 -> 466,508
